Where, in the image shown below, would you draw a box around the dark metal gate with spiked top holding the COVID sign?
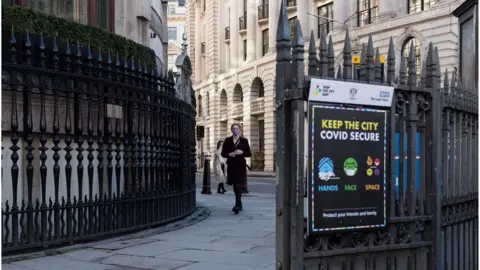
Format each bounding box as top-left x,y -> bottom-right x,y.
276,1 -> 478,270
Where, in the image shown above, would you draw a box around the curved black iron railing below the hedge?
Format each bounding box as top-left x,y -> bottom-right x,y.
2,30 -> 196,254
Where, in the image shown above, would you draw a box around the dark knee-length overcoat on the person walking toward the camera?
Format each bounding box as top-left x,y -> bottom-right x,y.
222,136 -> 252,186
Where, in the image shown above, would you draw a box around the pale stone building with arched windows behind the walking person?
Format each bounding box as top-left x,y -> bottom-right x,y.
187,0 -> 463,171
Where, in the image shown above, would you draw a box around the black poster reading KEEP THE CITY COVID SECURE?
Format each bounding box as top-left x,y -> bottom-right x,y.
308,104 -> 389,233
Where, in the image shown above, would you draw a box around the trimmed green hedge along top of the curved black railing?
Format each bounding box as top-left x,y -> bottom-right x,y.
2,6 -> 155,63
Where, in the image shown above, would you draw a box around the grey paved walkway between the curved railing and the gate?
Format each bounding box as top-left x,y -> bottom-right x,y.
2,186 -> 275,270
